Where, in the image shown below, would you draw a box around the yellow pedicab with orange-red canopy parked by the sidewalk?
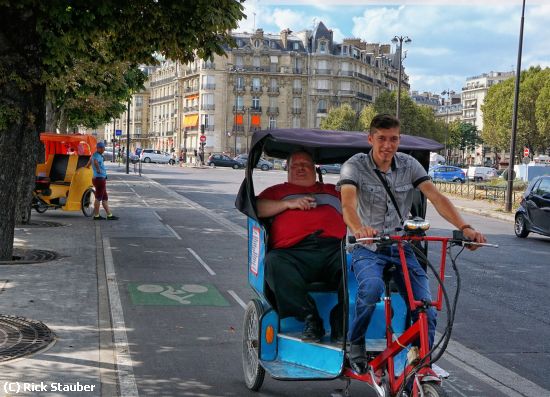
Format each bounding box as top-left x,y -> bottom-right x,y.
31,132 -> 96,216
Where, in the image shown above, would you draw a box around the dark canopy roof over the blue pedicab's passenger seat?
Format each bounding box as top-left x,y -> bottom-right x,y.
235,128 -> 444,220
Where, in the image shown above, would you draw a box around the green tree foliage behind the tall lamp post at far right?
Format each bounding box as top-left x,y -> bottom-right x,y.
481,67 -> 550,155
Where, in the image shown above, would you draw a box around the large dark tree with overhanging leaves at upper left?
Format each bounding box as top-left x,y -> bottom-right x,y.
0,0 -> 244,260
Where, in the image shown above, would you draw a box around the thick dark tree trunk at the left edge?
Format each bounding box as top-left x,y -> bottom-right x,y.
0,6 -> 45,260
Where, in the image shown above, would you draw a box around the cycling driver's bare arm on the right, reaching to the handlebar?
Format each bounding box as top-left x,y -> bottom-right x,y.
418,181 -> 487,249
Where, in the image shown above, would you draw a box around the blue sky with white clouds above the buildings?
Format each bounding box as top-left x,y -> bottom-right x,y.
239,0 -> 550,94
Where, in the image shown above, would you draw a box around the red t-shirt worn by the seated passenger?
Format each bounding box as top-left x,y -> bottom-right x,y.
258,182 -> 346,248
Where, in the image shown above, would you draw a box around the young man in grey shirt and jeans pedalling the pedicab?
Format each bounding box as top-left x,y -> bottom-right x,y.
338,114 -> 486,373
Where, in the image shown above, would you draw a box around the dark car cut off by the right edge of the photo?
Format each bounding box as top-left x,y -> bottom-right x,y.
514,175 -> 550,238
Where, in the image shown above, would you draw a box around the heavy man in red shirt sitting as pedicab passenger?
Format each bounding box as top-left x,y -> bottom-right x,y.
257,151 -> 346,342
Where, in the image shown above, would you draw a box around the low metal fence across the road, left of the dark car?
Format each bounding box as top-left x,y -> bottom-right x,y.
433,181 -> 523,206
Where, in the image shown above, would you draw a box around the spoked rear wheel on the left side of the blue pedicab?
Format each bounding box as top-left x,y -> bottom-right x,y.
243,299 -> 265,391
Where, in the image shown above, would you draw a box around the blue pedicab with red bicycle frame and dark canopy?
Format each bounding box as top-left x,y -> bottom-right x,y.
235,129 -> 496,397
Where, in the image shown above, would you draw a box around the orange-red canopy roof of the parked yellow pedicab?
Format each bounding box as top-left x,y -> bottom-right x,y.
40,132 -> 96,159
